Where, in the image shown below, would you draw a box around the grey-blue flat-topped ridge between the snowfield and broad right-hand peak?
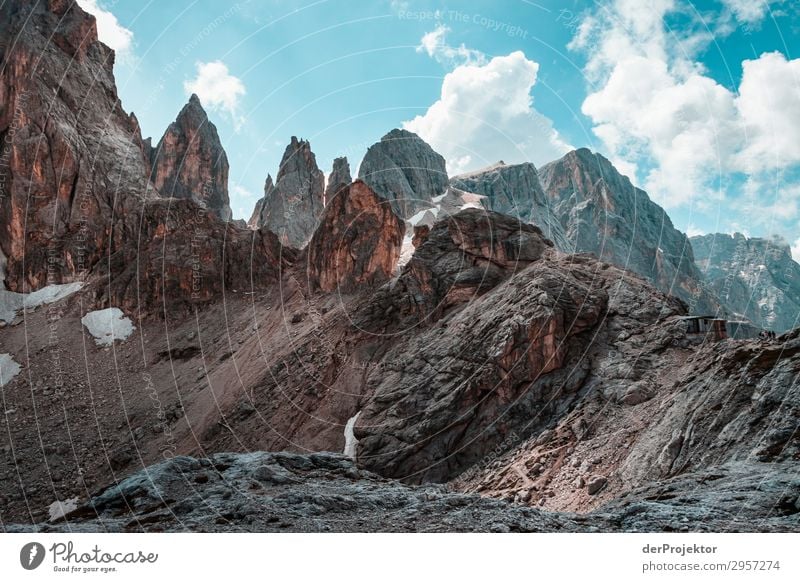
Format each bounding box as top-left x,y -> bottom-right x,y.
450,162 -> 572,252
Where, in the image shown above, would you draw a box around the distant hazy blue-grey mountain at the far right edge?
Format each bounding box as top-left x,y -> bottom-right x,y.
691,232 -> 800,332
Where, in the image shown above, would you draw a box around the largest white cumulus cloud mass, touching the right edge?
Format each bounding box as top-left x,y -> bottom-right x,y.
571,0 -> 800,214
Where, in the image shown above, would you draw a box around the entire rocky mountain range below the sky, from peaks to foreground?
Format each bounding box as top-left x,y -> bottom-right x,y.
0,0 -> 800,531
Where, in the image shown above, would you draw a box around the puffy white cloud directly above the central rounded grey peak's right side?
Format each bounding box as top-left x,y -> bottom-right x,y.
404,51 -> 572,174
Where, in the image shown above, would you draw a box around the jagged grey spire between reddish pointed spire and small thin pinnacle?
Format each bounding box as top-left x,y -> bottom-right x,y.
249,136 -> 325,249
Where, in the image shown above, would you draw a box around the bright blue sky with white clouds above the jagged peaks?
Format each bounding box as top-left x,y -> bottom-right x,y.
79,0 -> 800,259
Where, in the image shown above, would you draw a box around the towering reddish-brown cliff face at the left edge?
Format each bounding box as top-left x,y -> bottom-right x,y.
0,0 -> 148,291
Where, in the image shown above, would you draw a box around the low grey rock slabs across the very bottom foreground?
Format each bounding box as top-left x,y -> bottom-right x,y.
7,452 -> 800,533
